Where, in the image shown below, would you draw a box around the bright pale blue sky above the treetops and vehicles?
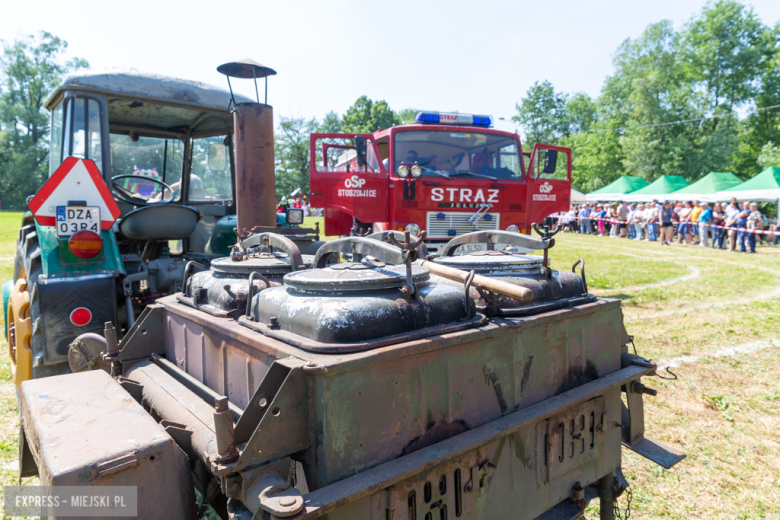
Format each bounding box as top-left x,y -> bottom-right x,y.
0,0 -> 780,133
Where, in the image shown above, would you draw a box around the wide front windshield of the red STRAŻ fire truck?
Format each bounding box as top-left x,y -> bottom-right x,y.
393,129 -> 522,180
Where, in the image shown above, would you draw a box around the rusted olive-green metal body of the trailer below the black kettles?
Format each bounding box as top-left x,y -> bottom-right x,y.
122,290 -> 636,518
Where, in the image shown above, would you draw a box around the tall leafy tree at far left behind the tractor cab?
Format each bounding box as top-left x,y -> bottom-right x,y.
0,32 -> 89,209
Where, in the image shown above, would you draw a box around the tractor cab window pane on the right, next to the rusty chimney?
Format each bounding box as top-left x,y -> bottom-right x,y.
189,135 -> 233,202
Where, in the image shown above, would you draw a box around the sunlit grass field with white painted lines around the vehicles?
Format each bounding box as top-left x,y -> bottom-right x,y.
0,212 -> 780,519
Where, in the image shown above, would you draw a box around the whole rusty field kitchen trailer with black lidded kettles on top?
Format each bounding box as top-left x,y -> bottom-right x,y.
20,62 -> 684,520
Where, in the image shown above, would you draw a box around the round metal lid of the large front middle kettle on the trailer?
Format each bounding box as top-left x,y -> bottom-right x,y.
284,262 -> 430,293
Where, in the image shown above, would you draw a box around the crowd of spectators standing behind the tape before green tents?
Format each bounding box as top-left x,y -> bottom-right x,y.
557,199 -> 778,253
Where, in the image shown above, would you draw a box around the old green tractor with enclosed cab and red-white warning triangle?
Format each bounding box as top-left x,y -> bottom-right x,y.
3,66 -> 318,387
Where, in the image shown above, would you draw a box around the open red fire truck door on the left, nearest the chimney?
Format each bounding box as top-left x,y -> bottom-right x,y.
310,134 -> 388,234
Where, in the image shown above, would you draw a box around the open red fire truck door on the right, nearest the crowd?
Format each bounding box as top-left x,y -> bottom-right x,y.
526,144 -> 571,226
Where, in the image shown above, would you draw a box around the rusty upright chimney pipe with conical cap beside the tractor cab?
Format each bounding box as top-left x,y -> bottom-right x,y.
217,59 -> 276,232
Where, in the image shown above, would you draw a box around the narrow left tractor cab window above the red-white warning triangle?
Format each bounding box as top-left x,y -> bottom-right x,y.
61,98 -> 103,173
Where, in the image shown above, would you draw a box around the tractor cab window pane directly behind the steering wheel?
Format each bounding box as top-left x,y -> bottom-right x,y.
111,133 -> 184,201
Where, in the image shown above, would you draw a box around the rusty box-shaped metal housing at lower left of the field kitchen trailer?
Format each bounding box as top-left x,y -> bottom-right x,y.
20,370 -> 195,518
